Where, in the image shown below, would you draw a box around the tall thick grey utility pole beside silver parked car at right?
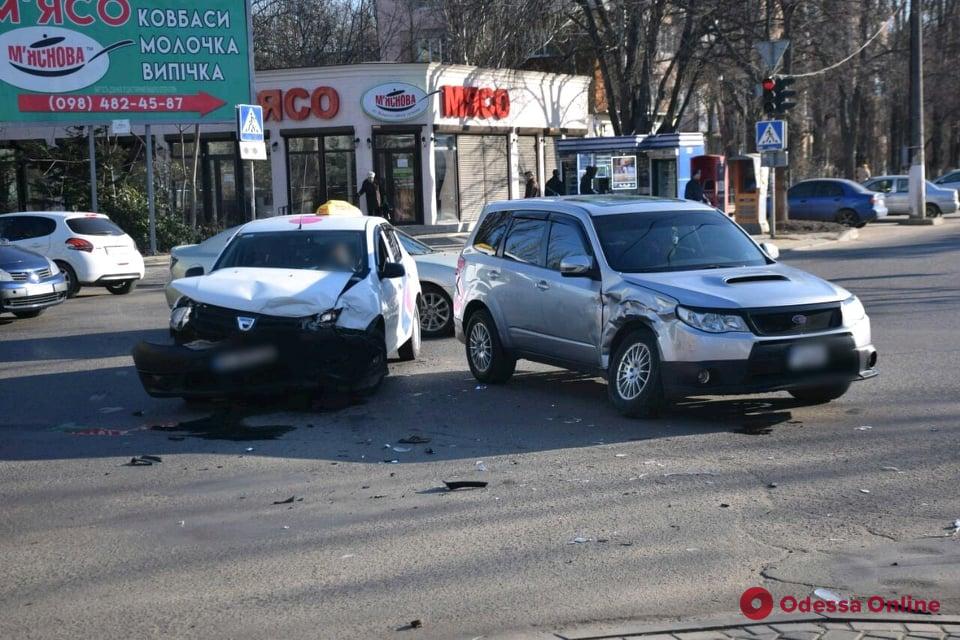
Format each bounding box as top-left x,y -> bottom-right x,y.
906,0 -> 943,224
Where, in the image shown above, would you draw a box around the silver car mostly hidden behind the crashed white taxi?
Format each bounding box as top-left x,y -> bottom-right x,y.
165,227 -> 457,338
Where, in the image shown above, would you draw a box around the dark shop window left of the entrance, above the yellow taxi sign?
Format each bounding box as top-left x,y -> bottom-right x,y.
286,134 -> 357,213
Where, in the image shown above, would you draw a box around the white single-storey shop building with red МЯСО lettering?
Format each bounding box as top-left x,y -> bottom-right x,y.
0,63 -> 593,228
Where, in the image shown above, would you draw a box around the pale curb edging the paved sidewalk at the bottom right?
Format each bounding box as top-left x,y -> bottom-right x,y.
552,613 -> 960,640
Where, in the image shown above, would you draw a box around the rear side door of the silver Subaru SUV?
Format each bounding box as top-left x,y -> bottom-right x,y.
490,211 -> 548,353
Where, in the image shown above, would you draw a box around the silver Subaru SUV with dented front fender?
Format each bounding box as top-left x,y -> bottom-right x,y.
454,196 -> 877,416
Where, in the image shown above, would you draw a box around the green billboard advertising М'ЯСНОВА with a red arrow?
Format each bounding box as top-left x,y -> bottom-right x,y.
0,0 -> 253,124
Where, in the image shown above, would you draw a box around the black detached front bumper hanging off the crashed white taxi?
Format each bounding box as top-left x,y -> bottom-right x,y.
133,327 -> 387,398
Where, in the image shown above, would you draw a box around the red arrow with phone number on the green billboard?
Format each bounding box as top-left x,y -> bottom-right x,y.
17,91 -> 226,116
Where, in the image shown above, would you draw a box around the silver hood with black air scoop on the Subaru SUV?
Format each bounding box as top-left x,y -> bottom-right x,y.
623,264 -> 850,309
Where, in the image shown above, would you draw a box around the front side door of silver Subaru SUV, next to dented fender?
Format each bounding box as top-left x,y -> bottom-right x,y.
537,214 -> 602,366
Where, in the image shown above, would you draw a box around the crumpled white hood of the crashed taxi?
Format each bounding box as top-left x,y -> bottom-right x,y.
170,267 -> 353,318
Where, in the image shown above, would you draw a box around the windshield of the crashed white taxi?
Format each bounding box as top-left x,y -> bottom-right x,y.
214,231 -> 367,273
